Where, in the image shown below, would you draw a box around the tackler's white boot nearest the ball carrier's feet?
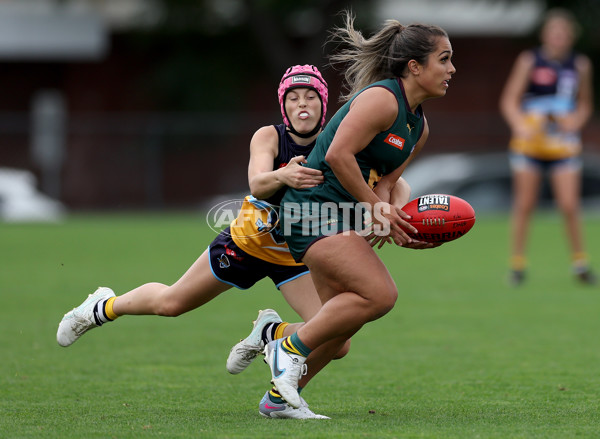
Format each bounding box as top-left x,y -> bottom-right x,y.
227,309 -> 281,375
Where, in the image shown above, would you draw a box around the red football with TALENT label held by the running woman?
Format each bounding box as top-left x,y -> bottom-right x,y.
402,194 -> 475,242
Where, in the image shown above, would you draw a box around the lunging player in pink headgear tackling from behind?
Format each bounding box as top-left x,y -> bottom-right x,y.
57,65 -> 349,419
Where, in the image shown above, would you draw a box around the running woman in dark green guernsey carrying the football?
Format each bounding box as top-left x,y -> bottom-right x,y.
265,14 -> 456,407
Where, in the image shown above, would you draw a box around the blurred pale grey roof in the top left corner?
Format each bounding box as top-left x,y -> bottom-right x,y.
0,0 -> 164,61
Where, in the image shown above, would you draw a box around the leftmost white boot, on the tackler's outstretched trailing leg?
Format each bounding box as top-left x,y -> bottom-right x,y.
56,287 -> 115,347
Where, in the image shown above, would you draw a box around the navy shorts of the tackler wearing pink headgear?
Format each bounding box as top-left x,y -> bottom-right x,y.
208,228 -> 308,290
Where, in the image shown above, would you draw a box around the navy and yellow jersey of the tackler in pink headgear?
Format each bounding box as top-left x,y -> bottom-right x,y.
230,124 -> 315,265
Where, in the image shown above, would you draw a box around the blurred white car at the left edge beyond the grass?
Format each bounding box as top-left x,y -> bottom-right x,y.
0,168 -> 65,222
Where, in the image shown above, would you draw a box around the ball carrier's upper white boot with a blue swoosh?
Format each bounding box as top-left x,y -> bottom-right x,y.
265,339 -> 307,409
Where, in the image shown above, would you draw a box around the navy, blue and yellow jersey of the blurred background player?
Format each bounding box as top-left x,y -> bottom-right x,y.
510,49 -> 581,160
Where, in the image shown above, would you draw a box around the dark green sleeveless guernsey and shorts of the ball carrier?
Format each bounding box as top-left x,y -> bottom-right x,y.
281,78 -> 424,260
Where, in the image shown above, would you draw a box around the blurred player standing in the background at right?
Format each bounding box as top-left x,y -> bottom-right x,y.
500,9 -> 596,286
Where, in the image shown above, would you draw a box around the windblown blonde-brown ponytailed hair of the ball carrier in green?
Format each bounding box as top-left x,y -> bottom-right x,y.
328,11 -> 448,101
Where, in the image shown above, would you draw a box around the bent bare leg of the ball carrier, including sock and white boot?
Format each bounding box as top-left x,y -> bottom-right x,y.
265,232 -> 398,407
